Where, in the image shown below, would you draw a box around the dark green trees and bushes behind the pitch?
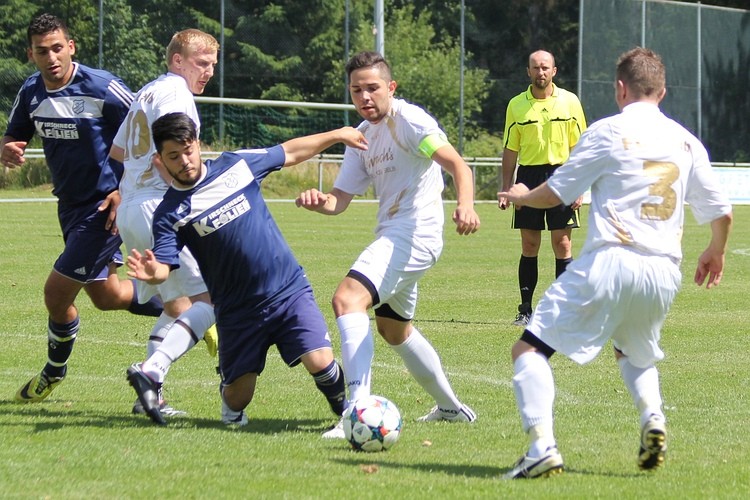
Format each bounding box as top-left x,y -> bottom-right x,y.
0,0 -> 747,161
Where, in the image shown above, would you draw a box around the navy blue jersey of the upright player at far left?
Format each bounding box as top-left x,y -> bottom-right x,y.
5,63 -> 133,205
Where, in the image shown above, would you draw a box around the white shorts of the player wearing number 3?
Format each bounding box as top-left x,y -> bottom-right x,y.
527,246 -> 682,368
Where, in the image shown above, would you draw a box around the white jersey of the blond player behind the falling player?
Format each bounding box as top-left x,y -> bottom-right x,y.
114,73 -> 200,202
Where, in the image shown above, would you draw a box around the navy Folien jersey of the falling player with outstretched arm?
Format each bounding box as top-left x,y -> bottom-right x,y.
153,146 -> 309,317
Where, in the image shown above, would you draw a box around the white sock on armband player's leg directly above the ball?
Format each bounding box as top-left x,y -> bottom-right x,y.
336,312 -> 375,403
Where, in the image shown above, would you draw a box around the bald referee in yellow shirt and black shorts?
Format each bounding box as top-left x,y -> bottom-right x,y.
498,50 -> 586,327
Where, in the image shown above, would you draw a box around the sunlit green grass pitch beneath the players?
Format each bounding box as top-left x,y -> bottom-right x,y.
0,197 -> 750,499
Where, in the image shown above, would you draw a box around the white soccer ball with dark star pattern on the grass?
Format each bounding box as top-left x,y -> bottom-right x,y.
343,396 -> 401,451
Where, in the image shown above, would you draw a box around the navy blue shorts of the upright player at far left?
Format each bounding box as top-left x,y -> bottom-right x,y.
53,200 -> 123,284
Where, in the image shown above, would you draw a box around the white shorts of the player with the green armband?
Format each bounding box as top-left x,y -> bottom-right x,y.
351,234 -> 443,319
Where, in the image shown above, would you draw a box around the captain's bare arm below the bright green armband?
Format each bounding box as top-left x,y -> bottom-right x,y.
432,144 -> 481,235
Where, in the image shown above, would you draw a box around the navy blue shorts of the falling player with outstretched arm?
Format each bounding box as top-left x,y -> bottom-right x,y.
215,286 -> 331,384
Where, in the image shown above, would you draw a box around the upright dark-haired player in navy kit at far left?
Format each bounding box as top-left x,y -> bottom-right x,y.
0,14 -> 161,402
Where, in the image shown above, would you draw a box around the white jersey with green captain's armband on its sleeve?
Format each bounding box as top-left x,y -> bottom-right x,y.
334,99 -> 445,248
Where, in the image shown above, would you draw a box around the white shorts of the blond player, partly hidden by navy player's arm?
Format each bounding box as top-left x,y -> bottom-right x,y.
117,198 -> 207,303
